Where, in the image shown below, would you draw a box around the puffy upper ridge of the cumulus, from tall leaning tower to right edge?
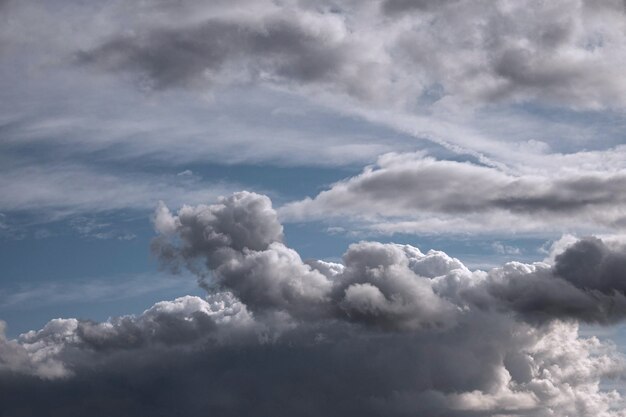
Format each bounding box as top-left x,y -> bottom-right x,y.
155,193 -> 626,330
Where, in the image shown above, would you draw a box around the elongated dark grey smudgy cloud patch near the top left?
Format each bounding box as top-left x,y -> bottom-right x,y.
77,15 -> 352,93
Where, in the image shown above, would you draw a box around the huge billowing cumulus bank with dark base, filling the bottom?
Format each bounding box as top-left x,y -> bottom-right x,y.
0,192 -> 624,416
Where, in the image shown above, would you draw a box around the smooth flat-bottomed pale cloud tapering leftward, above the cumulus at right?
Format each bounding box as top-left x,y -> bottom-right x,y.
280,153 -> 626,233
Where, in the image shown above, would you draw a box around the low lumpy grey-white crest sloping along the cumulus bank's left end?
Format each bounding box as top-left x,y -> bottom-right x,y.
4,293 -> 251,378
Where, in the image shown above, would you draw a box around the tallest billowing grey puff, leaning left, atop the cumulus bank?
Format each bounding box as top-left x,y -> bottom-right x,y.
152,192 -> 330,318
